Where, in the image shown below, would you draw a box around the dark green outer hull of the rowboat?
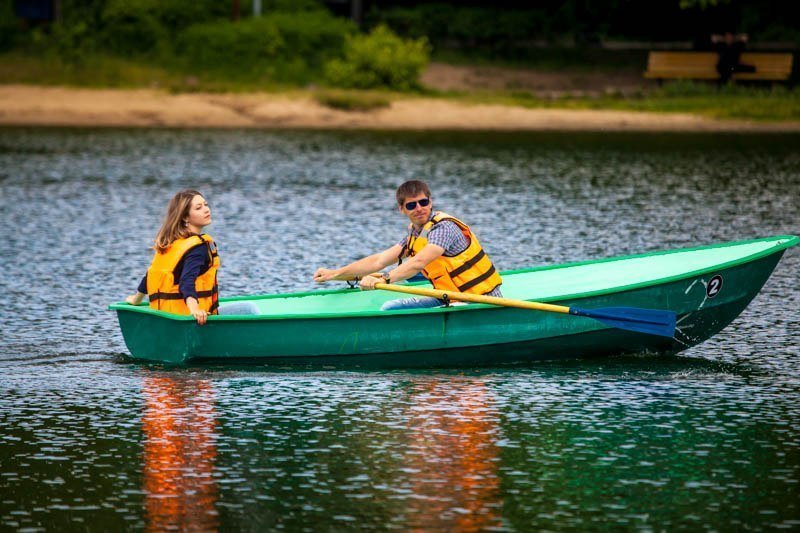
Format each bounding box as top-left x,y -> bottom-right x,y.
116,250 -> 784,368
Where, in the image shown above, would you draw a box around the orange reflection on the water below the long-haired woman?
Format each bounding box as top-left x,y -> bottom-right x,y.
142,376 -> 219,531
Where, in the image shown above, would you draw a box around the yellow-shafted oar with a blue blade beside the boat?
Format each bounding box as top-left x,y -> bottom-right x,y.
375,283 -> 675,338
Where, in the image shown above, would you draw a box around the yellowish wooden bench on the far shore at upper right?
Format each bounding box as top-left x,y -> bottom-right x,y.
644,52 -> 793,82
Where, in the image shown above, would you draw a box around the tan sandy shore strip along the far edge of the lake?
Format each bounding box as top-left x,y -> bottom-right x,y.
0,85 -> 800,132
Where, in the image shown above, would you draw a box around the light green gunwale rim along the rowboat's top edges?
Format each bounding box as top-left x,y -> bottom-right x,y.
108,235 -> 800,322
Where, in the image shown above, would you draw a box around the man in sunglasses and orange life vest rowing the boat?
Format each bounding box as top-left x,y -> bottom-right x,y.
314,180 -> 503,311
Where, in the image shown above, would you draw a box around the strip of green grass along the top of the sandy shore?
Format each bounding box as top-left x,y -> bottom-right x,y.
0,53 -> 800,122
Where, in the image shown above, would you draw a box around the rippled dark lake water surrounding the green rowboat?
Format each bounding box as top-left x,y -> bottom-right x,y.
0,129 -> 800,531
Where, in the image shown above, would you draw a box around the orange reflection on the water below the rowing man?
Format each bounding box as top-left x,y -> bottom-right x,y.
408,380 -> 502,531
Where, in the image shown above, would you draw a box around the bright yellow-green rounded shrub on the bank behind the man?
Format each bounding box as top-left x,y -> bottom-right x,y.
325,25 -> 430,91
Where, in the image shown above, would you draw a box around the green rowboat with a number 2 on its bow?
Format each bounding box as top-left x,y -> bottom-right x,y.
109,235 -> 800,368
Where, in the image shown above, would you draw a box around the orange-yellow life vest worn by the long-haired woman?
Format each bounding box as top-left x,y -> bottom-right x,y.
147,234 -> 220,315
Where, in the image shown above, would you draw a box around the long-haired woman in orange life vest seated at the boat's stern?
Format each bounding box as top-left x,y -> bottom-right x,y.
125,189 -> 220,325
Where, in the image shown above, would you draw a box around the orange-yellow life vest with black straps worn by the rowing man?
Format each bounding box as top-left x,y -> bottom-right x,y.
406,211 -> 503,294
